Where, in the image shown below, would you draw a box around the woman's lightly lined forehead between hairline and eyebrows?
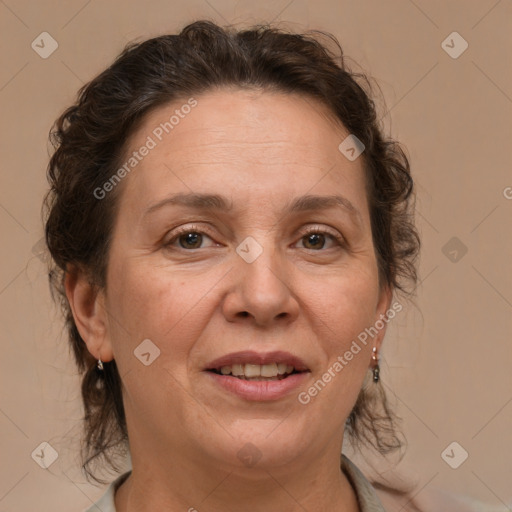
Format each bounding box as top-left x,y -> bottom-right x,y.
116,89 -> 366,220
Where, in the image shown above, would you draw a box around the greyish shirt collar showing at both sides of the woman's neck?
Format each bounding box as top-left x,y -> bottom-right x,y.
84,454 -> 386,512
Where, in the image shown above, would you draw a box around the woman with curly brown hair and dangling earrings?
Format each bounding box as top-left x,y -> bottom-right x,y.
46,21 -> 419,512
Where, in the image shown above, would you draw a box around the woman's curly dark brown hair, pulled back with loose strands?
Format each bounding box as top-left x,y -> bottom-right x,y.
44,21 -> 420,498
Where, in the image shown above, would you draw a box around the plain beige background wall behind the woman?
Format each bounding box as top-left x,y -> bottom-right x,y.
0,0 -> 512,512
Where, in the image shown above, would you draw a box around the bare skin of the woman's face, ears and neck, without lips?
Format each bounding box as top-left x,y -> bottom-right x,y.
67,89 -> 391,512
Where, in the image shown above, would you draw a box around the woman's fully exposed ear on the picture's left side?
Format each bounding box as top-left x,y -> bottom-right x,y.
65,267 -> 114,362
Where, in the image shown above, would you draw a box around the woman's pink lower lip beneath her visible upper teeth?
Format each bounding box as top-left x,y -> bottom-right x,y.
206,371 -> 309,402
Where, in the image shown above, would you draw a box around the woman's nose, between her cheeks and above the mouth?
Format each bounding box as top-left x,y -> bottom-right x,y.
223,244 -> 299,327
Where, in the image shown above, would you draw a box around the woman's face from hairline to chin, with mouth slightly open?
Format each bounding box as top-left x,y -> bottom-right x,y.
96,90 -> 390,468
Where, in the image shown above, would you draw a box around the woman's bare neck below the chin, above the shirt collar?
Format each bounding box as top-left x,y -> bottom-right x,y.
115,442 -> 360,512
